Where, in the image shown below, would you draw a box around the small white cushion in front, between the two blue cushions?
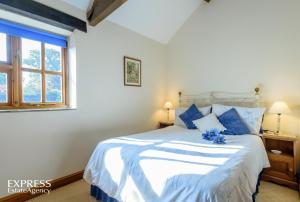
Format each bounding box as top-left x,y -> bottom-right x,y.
193,113 -> 226,133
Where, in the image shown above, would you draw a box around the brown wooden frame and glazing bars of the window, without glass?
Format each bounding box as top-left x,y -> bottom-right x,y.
0,35 -> 68,111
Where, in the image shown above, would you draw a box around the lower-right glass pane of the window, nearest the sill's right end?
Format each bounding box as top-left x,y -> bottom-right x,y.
46,74 -> 62,102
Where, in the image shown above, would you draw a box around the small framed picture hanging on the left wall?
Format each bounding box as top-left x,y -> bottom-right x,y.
124,56 -> 142,87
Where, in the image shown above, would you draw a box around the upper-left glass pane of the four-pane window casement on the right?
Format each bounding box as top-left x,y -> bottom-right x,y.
22,38 -> 41,69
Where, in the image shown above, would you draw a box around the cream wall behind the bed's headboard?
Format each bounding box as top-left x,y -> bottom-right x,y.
167,0 -> 300,134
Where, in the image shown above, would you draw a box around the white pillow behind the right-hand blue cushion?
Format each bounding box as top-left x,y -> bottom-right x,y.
212,104 -> 266,135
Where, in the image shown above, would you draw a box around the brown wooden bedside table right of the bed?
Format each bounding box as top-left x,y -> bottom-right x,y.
262,133 -> 300,190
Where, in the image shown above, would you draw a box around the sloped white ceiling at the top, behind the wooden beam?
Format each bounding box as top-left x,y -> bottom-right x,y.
63,0 -> 203,44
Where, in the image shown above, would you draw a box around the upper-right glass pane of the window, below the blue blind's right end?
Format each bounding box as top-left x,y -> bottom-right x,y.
45,44 -> 62,72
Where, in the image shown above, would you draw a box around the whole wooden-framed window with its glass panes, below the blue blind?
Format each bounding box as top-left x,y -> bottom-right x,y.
0,21 -> 67,109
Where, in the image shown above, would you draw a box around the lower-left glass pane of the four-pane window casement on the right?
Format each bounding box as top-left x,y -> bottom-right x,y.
22,72 -> 42,103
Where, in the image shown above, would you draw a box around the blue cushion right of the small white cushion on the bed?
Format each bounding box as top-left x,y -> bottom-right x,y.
218,108 -> 251,135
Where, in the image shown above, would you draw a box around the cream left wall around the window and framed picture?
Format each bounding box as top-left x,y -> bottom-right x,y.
0,1 -> 166,196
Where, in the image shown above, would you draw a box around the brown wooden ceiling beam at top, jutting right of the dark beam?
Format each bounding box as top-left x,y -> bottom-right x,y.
87,0 -> 127,26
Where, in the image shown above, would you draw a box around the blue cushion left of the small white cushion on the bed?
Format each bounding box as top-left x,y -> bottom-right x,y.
179,104 -> 203,129
